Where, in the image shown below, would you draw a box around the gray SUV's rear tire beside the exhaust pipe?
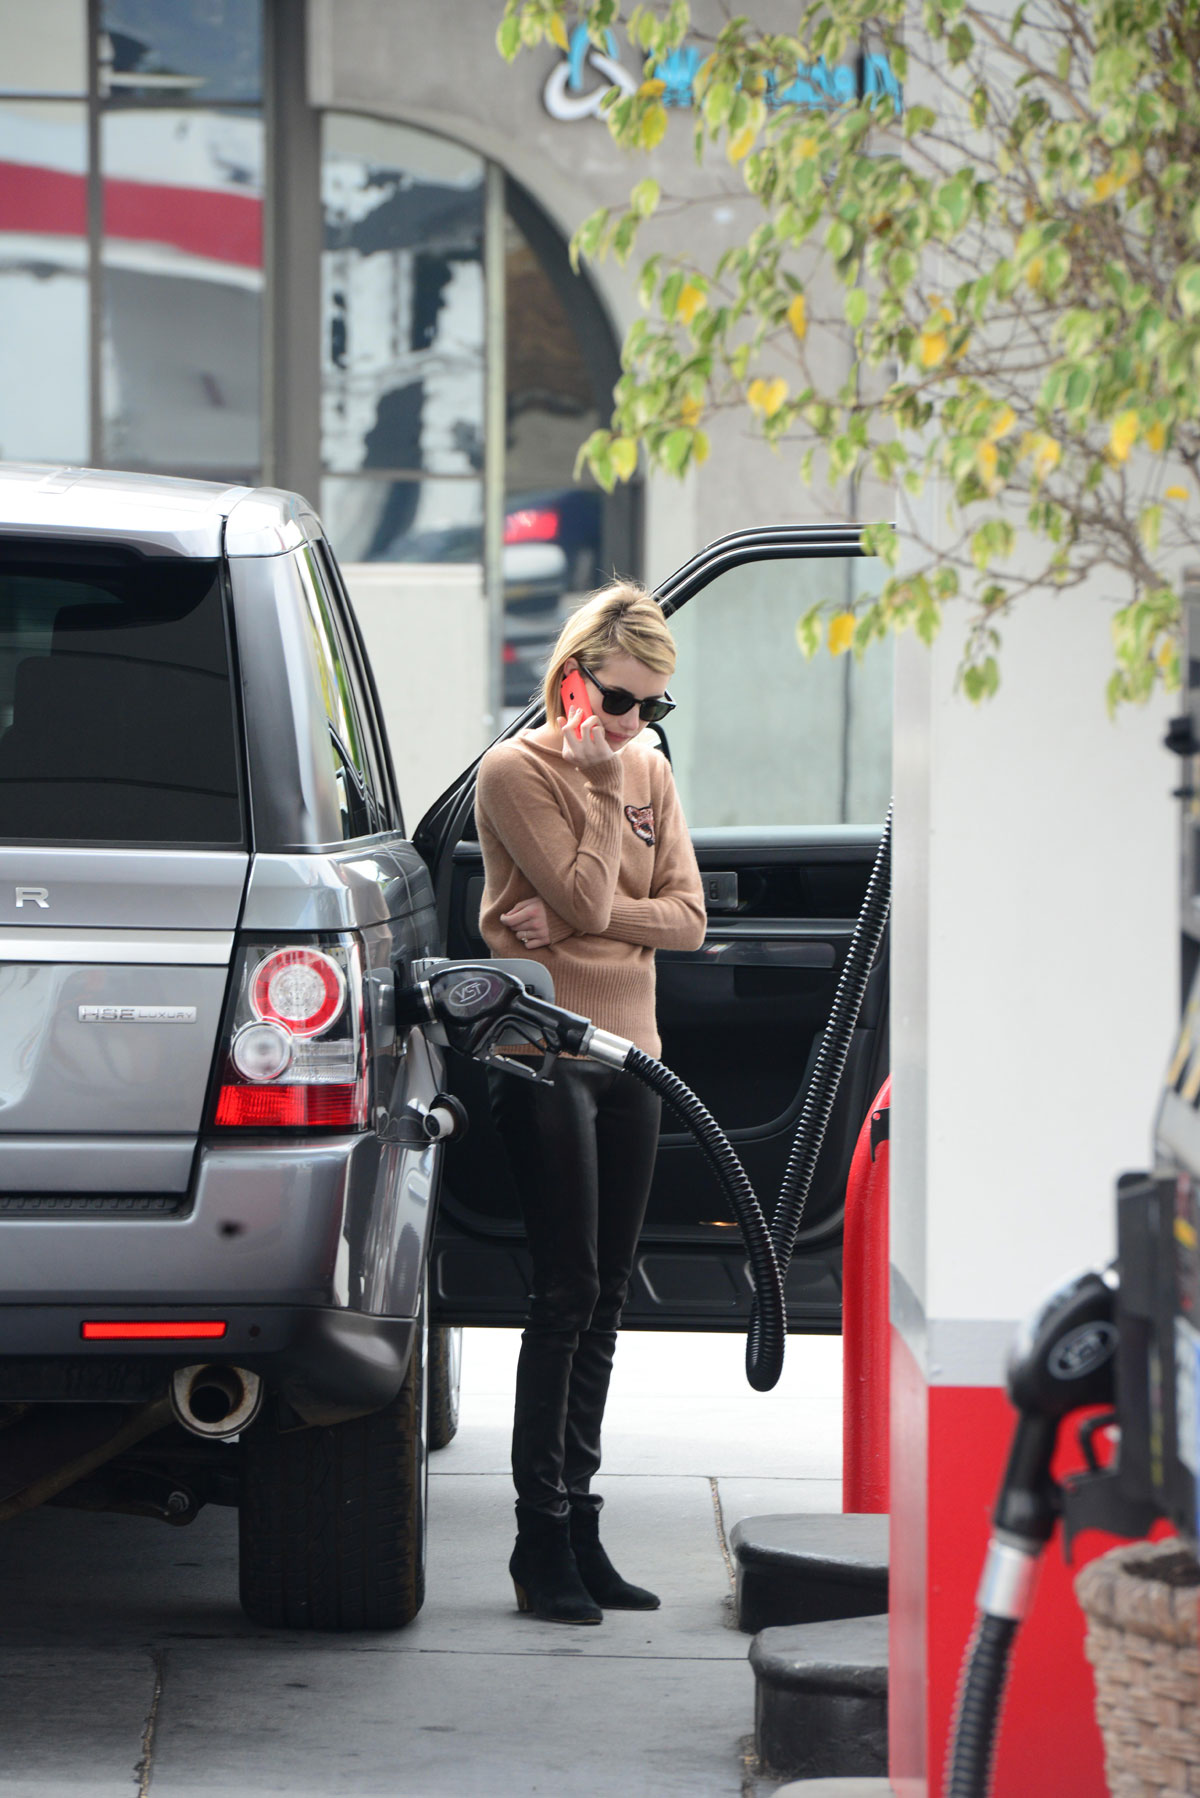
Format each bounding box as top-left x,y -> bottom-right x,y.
237,1309 -> 428,1629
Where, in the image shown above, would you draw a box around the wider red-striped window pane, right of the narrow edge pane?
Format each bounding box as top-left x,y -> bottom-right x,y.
101,104 -> 264,480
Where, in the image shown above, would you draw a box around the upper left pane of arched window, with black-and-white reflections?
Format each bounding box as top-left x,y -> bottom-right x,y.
322,113 -> 484,492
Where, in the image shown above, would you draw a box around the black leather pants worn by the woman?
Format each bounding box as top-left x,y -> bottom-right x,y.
489,1061 -> 662,1518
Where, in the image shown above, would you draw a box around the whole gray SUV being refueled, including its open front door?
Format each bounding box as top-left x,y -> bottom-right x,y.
0,467 -> 887,1629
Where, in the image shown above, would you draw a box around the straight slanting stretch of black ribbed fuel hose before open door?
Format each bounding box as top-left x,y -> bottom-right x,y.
766,804 -> 892,1287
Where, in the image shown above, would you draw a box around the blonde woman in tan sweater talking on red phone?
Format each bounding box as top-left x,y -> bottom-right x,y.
475,581 -> 705,1624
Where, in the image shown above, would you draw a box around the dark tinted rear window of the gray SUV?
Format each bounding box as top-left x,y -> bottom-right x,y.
0,543 -> 245,849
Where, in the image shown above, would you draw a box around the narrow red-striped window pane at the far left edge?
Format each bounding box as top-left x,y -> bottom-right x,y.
0,101 -> 90,462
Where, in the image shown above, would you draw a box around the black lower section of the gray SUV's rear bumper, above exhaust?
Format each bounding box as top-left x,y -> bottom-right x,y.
0,1304 -> 416,1424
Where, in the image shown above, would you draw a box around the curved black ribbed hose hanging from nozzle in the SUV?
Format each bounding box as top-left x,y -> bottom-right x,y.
624,1048 -> 788,1392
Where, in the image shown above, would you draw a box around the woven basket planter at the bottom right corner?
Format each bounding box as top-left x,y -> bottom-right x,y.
1076,1539 -> 1200,1798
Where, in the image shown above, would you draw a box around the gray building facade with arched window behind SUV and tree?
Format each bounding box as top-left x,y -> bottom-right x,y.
0,0 -> 891,823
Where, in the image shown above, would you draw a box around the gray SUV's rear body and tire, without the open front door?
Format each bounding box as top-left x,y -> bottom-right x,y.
0,466 -> 453,1629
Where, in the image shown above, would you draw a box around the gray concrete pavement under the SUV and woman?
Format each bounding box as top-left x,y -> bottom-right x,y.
0,1331 -> 840,1798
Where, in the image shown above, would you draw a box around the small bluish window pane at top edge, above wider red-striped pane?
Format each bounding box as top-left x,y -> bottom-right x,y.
99,0 -> 263,106
